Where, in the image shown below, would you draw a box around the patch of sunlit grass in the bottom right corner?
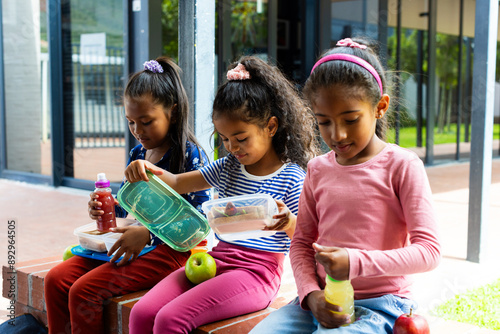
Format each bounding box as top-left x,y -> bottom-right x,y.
434,279 -> 500,330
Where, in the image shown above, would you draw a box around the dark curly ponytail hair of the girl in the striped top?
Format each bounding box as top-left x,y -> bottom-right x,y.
212,56 -> 320,169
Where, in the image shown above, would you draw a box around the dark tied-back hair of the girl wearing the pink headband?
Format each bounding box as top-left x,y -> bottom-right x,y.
303,38 -> 388,140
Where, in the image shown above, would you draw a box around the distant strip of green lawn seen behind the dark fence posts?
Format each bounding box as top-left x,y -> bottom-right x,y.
387,124 -> 500,147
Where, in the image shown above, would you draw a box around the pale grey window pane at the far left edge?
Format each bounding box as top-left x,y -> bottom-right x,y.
2,0 -> 52,175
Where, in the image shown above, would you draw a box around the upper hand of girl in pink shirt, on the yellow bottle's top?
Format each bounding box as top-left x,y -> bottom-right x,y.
313,243 -> 349,281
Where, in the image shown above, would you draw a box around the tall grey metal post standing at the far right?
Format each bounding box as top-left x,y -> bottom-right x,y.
467,0 -> 498,262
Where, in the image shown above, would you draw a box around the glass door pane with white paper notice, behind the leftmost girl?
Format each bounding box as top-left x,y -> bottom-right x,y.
63,0 -> 128,182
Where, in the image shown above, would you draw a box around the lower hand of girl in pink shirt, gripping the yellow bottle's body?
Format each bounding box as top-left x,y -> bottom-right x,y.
306,290 -> 351,328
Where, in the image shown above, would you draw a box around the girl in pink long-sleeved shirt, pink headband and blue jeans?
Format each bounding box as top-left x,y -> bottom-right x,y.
251,39 -> 441,334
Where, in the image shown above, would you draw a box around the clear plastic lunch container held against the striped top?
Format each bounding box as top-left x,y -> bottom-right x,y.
202,194 -> 278,241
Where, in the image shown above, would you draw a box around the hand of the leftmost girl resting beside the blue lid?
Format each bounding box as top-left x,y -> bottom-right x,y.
108,226 -> 150,267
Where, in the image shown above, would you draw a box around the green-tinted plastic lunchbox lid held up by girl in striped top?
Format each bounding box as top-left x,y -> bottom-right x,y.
117,171 -> 210,252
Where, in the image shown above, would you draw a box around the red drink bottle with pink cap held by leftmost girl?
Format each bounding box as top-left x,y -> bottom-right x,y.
94,173 -> 116,232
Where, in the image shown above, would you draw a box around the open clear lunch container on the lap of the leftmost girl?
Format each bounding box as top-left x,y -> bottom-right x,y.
73,218 -> 139,252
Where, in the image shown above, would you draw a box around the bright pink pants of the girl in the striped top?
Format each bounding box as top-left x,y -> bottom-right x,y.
129,241 -> 285,334
